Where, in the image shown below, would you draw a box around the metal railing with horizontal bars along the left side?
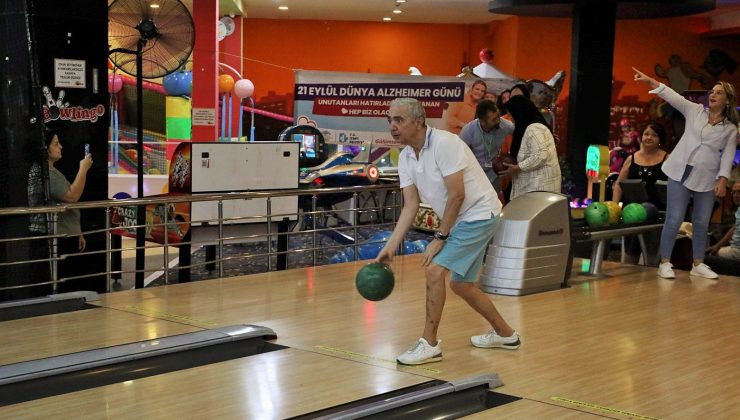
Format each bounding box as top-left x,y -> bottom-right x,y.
0,184 -> 403,291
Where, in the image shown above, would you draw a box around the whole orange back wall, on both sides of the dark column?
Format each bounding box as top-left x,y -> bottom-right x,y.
244,17 -> 740,107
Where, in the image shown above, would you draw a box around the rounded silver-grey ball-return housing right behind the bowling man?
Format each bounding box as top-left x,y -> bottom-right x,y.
481,191 -> 571,296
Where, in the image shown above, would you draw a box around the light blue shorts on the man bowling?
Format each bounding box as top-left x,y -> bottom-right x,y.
432,215 -> 498,283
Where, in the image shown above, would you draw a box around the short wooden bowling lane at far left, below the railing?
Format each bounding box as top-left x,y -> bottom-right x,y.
0,308 -> 201,365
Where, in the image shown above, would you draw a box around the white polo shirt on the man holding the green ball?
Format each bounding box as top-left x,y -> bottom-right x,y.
398,127 -> 501,224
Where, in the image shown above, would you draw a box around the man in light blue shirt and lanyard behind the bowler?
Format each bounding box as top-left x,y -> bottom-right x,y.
460,99 -> 514,193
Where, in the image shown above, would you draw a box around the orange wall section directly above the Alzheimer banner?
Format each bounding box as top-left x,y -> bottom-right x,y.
244,19 -> 488,98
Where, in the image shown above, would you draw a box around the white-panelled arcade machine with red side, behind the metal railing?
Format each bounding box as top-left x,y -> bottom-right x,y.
111,142 -> 299,281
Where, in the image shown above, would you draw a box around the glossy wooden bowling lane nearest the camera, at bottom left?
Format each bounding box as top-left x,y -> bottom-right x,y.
0,349 -> 429,419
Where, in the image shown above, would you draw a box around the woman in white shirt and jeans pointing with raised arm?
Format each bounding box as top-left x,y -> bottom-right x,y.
632,67 -> 738,279
